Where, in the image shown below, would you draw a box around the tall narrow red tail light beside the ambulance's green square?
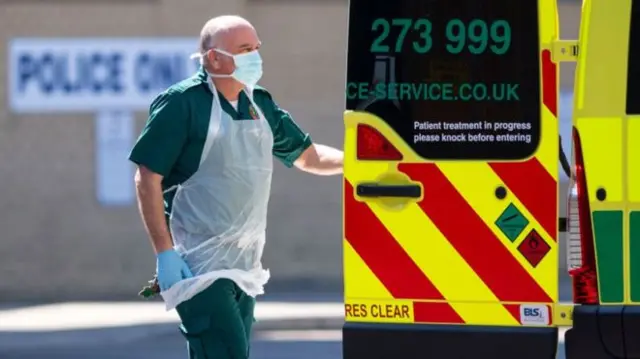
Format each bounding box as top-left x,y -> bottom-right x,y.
569,127 -> 599,304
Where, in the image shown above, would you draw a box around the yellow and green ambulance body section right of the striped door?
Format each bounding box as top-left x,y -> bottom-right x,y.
565,0 -> 640,359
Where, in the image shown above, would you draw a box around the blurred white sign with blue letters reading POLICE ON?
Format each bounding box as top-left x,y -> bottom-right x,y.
9,38 -> 199,113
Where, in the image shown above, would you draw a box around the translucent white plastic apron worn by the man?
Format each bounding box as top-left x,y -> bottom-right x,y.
161,79 -> 273,310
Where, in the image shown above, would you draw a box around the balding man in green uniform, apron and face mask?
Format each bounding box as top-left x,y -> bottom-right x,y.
129,16 -> 343,359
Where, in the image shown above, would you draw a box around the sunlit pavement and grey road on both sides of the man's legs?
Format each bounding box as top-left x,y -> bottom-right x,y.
0,297 -> 564,359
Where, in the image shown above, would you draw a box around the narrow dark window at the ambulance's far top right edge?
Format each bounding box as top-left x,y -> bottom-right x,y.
627,0 -> 640,115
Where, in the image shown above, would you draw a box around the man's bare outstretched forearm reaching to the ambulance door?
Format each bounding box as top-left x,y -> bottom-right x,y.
294,144 -> 344,176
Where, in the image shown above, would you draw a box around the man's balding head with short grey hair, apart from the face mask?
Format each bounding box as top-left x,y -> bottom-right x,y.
200,15 -> 261,83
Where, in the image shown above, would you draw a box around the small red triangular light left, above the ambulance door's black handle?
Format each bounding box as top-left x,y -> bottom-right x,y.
356,124 -> 402,161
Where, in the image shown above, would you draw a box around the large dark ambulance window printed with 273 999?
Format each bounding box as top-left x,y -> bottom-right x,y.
346,0 -> 541,160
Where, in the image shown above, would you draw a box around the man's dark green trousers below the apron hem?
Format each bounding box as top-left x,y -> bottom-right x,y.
176,279 -> 255,359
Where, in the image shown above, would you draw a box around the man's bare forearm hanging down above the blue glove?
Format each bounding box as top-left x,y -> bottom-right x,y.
136,180 -> 173,254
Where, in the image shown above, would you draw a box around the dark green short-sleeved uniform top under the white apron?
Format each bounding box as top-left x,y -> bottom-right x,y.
129,68 -> 311,215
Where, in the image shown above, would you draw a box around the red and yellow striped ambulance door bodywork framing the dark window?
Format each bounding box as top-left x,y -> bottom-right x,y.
343,1 -> 558,326
